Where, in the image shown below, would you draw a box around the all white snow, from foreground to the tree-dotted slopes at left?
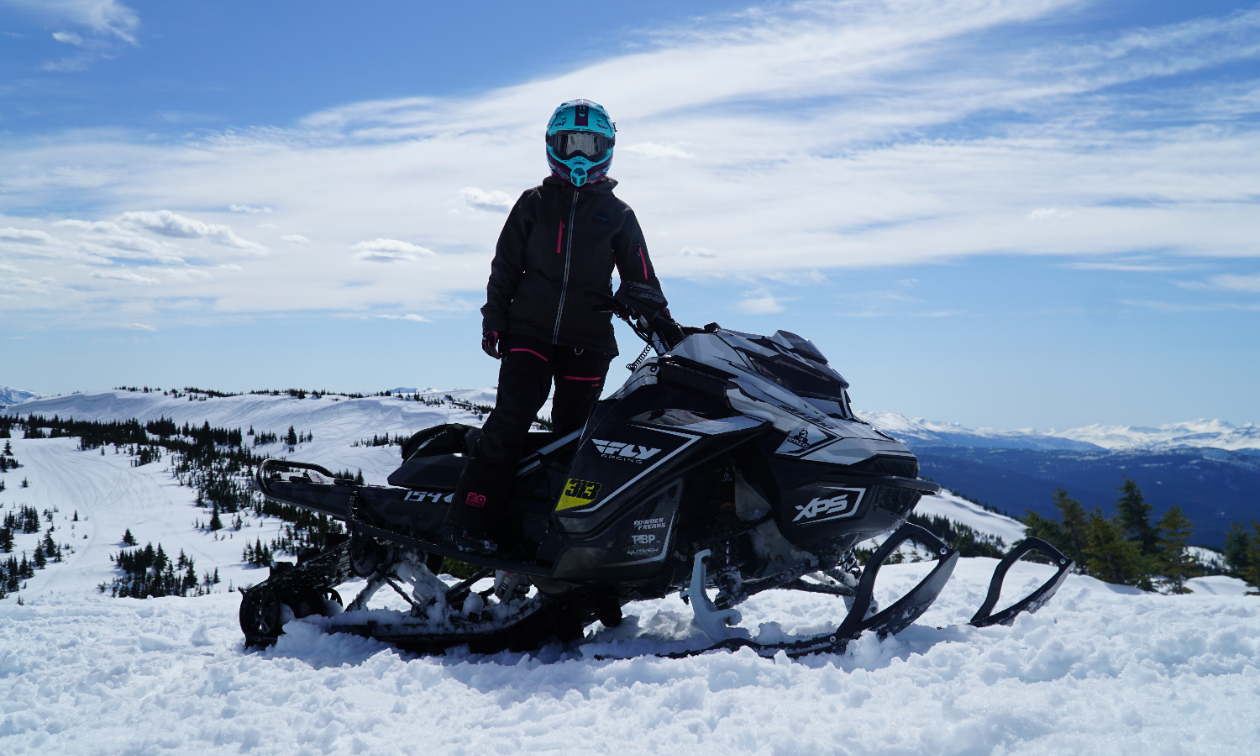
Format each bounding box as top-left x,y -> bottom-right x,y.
0,392 -> 1260,756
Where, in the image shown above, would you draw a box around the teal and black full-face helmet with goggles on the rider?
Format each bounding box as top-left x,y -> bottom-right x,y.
547,100 -> 617,186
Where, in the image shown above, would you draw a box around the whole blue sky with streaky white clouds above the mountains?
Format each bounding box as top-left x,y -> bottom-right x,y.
0,0 -> 1260,428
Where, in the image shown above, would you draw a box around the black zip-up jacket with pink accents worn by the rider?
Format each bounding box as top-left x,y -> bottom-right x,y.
481,176 -> 660,354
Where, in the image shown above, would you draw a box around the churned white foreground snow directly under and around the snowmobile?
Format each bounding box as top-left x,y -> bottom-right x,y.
0,551 -> 1260,756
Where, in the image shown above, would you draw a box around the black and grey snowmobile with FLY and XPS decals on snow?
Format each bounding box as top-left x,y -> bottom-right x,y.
241,285 -> 1072,656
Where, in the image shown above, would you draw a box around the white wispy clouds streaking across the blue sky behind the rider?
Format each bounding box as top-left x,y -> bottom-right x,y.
0,0 -> 1260,330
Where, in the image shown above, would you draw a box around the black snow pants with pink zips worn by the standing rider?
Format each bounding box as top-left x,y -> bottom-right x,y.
446,334 -> 614,532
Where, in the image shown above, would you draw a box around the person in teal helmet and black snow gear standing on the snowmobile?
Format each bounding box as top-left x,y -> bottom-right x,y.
446,100 -> 680,551
